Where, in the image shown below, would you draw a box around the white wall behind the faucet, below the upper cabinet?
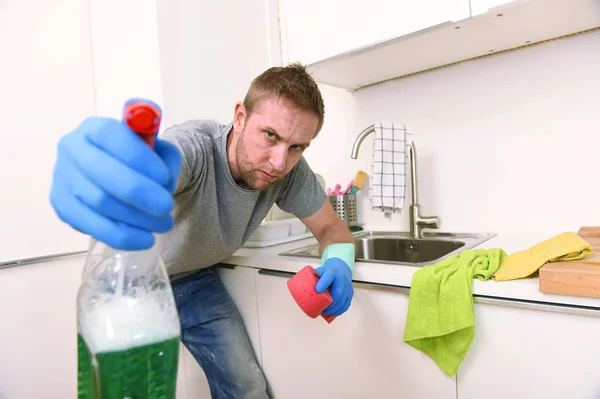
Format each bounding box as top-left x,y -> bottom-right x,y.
306,32 -> 600,251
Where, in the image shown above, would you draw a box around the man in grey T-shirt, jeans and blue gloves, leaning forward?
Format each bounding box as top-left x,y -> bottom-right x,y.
50,64 -> 355,399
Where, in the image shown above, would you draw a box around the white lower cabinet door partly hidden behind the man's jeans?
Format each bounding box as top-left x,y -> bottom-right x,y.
183,266 -> 260,399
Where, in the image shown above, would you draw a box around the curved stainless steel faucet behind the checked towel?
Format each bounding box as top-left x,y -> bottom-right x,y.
350,125 -> 441,238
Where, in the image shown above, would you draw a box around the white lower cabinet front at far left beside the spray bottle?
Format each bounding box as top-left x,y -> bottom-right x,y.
0,256 -> 86,399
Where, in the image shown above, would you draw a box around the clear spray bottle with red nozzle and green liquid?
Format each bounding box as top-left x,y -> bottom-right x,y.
77,100 -> 181,399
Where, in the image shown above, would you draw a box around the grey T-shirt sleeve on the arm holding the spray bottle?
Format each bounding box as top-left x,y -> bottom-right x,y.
158,122 -> 205,194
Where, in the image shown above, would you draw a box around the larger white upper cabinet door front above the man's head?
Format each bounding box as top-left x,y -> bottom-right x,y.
279,0 -> 470,63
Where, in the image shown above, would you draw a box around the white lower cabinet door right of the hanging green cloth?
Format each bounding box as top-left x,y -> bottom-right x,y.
457,302 -> 600,399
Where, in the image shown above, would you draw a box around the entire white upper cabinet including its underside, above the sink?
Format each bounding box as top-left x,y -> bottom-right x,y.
279,0 -> 600,91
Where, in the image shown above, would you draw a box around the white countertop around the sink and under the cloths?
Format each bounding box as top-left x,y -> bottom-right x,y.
223,234 -> 600,309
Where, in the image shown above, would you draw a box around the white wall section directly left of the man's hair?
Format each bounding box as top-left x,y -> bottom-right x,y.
158,0 -> 279,128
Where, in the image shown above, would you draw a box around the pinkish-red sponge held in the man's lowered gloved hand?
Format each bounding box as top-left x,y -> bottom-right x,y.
287,266 -> 335,323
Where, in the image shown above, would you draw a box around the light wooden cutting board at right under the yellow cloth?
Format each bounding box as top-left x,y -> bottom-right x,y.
539,226 -> 600,298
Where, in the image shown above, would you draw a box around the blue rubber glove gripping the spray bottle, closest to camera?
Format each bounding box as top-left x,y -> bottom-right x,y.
50,102 -> 181,250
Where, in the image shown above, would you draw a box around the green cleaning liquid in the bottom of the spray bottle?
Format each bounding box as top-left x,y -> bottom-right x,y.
77,335 -> 179,399
